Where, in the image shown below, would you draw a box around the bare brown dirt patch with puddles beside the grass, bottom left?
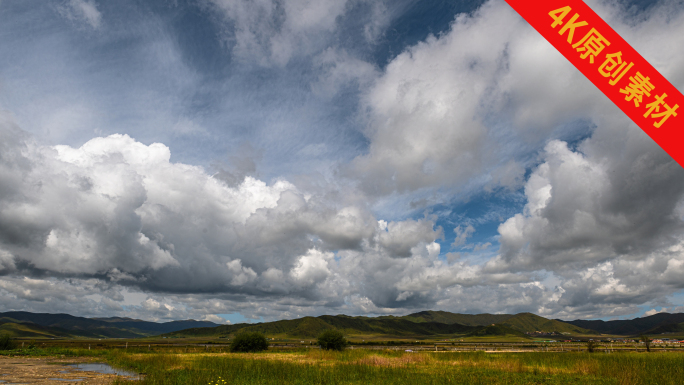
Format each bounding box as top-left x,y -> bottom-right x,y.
0,357 -> 134,385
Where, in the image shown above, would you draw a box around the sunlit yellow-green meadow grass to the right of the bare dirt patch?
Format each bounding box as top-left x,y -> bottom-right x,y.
99,349 -> 684,385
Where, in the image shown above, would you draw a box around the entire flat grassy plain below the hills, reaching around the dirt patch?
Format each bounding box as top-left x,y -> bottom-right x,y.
0,340 -> 684,385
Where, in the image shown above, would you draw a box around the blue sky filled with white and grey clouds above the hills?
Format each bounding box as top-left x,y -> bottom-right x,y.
0,0 -> 684,323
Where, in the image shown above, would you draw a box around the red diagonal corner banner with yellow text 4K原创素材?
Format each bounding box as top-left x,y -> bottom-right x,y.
506,0 -> 684,167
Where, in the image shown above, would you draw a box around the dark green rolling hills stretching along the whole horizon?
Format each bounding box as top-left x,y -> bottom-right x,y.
0,311 -> 684,339
